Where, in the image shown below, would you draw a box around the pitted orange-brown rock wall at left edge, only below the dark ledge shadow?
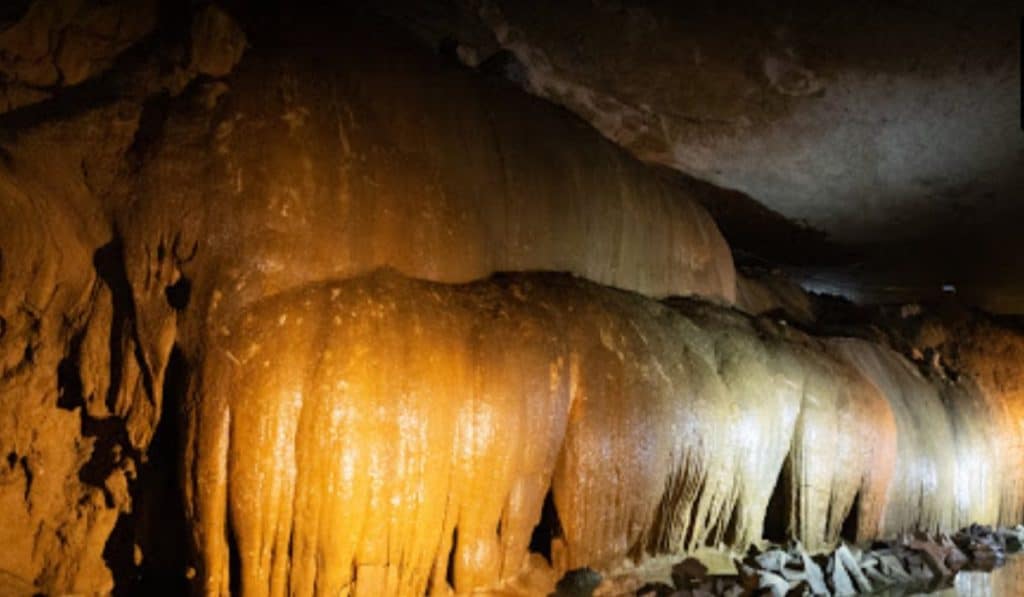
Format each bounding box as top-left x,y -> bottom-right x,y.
0,98 -> 144,594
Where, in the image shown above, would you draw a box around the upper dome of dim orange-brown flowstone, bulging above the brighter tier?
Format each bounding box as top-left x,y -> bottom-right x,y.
121,12 -> 735,321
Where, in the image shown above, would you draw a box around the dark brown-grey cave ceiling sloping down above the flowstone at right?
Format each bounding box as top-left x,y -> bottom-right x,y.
376,0 -> 1024,308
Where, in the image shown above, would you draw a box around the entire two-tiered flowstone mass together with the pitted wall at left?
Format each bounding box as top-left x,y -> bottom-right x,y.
0,1 -> 1024,596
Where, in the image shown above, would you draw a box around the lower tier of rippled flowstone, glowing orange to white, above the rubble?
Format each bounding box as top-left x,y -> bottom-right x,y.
186,271 -> 999,595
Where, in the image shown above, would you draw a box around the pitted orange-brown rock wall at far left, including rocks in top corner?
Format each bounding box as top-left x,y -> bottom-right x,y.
0,2 -> 247,595
